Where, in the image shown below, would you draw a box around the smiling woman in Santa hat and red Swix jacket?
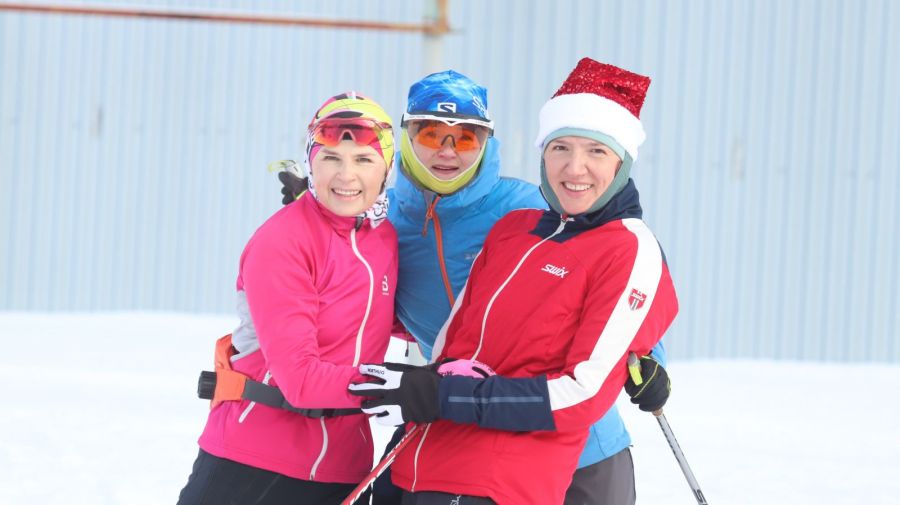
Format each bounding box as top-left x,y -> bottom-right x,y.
351,58 -> 678,505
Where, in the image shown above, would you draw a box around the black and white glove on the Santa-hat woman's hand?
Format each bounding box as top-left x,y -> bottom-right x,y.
348,363 -> 441,426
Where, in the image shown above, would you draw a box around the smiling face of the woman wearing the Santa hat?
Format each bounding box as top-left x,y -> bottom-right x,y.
544,136 -> 622,215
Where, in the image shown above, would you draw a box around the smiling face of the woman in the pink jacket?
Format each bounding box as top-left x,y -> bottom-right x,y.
312,140 -> 387,216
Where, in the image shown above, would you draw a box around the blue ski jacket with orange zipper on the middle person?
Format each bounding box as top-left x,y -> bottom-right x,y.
388,137 -> 665,468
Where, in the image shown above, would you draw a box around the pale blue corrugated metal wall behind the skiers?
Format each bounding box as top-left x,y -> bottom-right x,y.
0,0 -> 900,362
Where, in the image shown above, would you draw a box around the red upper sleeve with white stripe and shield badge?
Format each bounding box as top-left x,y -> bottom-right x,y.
547,219 -> 678,430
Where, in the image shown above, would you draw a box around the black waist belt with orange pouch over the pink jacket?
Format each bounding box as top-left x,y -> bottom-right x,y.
197,370 -> 362,418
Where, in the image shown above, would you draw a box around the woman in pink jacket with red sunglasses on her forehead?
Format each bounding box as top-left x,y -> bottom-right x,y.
178,92 -> 397,505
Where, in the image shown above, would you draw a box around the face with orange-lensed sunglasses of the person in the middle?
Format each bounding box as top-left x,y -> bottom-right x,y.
407,121 -> 488,181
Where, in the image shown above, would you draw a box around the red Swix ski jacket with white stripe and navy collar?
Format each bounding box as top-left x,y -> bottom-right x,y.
393,182 -> 678,505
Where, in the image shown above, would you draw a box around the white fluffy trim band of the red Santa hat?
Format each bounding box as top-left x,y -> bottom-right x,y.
534,93 -> 647,161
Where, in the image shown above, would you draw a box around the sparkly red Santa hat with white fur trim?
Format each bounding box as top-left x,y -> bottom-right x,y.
535,58 -> 650,161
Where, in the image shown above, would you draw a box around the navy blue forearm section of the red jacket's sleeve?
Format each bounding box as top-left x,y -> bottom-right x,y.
438,375 -> 556,431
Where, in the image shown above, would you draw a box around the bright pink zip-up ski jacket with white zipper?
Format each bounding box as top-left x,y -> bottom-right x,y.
200,193 -> 397,483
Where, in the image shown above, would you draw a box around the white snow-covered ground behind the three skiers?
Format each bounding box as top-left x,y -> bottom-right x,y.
0,313 -> 900,505
